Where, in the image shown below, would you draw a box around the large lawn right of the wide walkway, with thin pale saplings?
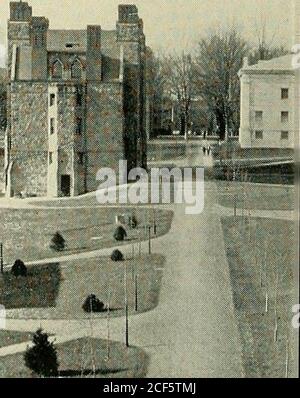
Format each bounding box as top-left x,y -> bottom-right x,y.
222,217 -> 297,378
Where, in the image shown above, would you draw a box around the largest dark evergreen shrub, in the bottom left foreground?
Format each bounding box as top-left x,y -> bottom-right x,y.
24,329 -> 58,377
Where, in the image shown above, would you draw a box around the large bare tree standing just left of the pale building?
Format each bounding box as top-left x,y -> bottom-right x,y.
196,27 -> 248,139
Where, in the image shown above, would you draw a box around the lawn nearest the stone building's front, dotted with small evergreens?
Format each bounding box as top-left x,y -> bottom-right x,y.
0,207 -> 173,264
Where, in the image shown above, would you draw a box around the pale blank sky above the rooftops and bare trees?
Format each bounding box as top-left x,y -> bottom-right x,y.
0,0 -> 294,66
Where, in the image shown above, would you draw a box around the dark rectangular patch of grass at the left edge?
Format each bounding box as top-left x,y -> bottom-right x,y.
0,264 -> 61,309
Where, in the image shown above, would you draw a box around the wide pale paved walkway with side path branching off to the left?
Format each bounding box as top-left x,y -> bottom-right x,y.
0,145 -> 243,378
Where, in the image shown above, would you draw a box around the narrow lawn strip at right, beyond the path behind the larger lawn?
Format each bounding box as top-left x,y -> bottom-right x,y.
217,181 -> 295,210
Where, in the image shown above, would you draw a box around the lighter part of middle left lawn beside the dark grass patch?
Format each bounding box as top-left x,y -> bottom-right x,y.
8,253 -> 164,319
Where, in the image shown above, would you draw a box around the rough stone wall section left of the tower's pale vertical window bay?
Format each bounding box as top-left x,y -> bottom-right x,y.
10,82 -> 48,195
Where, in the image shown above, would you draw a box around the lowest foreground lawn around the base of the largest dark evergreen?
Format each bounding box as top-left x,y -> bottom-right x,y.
0,338 -> 149,379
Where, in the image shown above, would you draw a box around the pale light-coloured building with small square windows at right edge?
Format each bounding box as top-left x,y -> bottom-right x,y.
239,54 -> 299,148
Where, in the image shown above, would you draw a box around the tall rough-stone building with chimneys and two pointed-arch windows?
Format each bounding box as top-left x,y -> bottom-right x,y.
5,2 -> 147,197
